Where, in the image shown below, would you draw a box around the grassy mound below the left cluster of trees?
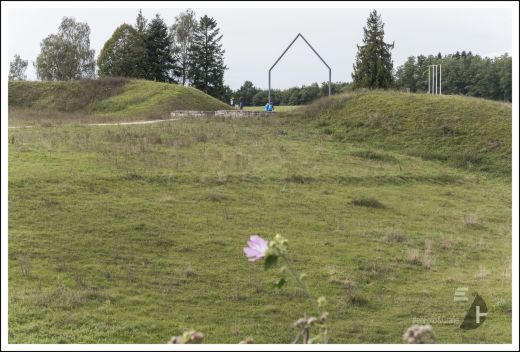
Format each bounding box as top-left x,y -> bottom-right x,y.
8,78 -> 228,118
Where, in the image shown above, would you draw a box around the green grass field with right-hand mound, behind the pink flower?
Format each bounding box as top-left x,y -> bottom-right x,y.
8,85 -> 512,343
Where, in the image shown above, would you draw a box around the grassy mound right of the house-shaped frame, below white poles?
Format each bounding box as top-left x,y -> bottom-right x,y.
295,91 -> 512,176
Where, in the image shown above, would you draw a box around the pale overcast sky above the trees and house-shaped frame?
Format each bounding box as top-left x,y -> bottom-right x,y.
8,6 -> 513,89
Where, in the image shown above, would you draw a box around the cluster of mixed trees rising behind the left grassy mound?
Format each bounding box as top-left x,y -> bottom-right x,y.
9,10 -> 231,100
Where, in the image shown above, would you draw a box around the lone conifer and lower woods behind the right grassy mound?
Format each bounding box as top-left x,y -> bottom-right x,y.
352,10 -> 513,101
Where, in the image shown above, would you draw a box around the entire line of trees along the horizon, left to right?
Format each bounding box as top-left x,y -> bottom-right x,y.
9,10 -> 512,105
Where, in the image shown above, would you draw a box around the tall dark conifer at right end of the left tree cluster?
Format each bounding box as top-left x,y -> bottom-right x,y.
189,15 -> 227,99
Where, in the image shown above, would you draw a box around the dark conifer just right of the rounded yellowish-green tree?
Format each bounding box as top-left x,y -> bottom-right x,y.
145,14 -> 178,82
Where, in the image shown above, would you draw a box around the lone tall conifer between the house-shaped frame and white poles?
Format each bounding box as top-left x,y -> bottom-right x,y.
352,10 -> 394,89
